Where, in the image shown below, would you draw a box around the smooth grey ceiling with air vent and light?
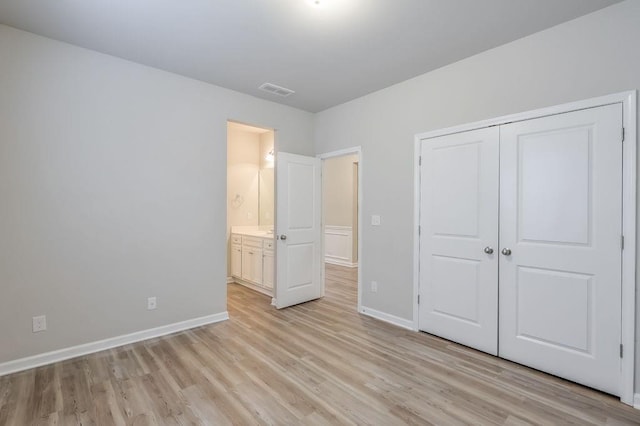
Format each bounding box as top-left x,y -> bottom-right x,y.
0,0 -> 619,112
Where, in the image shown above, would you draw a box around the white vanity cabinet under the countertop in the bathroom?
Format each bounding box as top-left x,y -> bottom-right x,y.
231,234 -> 275,295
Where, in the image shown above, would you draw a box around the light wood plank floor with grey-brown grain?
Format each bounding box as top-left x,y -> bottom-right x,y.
0,266 -> 640,425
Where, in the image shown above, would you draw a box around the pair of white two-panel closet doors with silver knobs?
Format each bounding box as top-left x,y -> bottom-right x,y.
419,104 -> 622,395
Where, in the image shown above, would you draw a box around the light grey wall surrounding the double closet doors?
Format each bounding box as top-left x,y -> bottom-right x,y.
316,0 -> 640,388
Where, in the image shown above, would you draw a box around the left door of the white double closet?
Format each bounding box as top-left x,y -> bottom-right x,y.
419,127 -> 499,355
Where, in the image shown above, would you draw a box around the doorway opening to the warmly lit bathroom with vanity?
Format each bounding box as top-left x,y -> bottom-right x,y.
227,121 -> 275,297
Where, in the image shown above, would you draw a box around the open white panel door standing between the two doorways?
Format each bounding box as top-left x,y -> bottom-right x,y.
274,152 -> 324,309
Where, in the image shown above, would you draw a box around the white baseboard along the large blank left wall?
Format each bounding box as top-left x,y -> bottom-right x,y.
0,311 -> 229,376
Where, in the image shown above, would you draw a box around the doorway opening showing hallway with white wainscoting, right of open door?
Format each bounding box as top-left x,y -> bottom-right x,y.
319,147 -> 362,312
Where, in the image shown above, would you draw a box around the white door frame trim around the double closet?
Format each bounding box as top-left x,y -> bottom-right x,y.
413,90 -> 638,405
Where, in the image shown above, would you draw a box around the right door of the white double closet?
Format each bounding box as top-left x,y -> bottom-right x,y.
499,104 -> 620,395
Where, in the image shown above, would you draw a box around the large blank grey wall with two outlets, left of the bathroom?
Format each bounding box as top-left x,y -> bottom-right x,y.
0,26 -> 314,363
